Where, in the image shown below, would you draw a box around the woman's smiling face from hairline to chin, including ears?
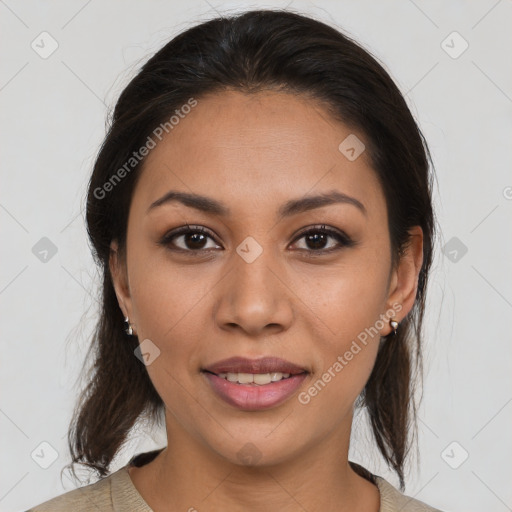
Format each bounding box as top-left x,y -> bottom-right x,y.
111,92 -> 421,464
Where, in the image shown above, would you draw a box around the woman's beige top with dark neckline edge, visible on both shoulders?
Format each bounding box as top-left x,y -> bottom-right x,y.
27,452 -> 441,512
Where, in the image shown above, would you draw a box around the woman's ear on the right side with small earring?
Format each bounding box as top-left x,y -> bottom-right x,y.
381,226 -> 423,336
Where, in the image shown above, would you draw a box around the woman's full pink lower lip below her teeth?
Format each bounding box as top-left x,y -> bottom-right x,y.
203,372 -> 307,411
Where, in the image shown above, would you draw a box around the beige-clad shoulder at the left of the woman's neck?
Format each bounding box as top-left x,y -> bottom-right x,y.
27,466 -> 151,512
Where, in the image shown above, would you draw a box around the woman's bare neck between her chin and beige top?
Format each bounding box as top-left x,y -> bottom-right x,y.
130,419 -> 380,512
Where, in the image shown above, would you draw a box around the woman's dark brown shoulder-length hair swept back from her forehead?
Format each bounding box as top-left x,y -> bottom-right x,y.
68,10 -> 435,489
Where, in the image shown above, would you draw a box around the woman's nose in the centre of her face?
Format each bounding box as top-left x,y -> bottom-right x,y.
215,246 -> 294,337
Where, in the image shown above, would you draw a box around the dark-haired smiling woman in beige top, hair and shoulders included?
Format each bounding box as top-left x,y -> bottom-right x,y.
28,11 -> 444,512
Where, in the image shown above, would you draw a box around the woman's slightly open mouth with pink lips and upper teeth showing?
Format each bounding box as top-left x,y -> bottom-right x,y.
202,357 -> 309,411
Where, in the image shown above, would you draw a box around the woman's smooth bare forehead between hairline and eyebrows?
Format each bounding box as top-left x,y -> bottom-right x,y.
134,91 -> 383,219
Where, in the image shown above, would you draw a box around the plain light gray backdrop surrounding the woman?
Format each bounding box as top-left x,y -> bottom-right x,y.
0,0 -> 512,512
